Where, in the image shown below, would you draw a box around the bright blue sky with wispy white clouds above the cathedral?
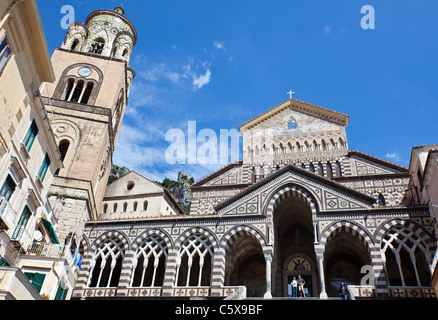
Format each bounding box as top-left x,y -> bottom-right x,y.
37,0 -> 438,180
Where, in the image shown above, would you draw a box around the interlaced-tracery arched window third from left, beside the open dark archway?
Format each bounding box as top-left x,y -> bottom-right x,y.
175,233 -> 214,287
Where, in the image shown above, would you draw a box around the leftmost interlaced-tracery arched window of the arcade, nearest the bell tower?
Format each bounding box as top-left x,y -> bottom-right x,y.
88,238 -> 125,288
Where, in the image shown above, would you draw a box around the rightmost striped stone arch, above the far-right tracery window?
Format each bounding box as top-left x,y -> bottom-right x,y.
375,218 -> 436,255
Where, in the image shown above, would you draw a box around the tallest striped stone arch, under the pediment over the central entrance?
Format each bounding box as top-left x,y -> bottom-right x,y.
264,183 -> 318,218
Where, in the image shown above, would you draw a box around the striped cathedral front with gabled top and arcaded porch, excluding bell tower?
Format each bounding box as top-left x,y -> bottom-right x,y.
73,99 -> 436,299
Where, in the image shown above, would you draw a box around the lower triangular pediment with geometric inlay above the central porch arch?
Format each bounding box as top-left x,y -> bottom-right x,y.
215,166 -> 375,215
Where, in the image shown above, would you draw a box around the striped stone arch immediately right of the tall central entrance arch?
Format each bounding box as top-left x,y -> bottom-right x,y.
319,220 -> 374,253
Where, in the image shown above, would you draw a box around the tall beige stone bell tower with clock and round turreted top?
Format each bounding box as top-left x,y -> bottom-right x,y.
40,7 -> 137,243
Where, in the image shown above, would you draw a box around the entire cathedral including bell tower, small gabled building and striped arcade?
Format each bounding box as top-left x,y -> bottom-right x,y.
37,7 -> 436,299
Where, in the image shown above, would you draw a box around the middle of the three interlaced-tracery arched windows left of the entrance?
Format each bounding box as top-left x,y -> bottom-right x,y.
131,235 -> 168,287
